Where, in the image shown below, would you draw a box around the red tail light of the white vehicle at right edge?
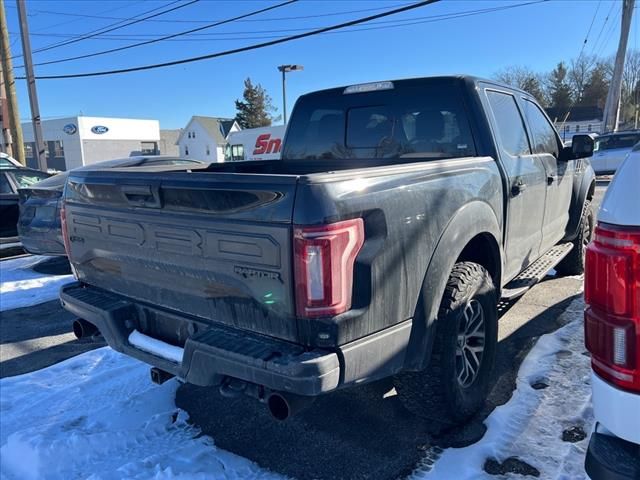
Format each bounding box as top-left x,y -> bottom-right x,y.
585,224 -> 640,392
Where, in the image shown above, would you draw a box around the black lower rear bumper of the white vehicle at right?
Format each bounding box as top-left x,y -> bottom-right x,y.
584,426 -> 640,480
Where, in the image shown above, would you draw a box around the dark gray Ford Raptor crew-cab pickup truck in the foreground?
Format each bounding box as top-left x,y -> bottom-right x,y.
61,76 -> 595,428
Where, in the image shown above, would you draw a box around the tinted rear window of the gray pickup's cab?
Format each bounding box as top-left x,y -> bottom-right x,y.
283,82 -> 476,161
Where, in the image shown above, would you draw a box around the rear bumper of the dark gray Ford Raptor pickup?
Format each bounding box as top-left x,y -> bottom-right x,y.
60,283 -> 411,396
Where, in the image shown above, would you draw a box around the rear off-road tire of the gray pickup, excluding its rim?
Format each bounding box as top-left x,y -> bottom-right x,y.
394,262 -> 498,434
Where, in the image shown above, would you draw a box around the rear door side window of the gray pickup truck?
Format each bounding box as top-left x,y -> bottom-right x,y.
487,90 -> 531,157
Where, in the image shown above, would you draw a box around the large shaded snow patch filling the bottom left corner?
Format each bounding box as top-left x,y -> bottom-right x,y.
0,347 -> 281,480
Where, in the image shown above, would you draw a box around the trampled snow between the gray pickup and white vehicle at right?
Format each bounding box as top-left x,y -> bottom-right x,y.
414,300 -> 594,480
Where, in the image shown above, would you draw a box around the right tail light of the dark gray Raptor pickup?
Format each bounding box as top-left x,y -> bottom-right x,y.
293,218 -> 364,317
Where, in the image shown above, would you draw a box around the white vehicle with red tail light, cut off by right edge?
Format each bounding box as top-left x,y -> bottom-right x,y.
585,146 -> 640,480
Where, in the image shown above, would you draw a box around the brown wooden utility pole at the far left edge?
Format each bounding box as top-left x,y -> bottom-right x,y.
0,0 -> 27,165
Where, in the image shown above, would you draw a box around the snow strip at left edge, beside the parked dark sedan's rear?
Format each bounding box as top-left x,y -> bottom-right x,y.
0,255 -> 73,311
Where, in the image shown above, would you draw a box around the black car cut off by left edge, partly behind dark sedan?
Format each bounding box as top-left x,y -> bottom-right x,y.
0,167 -> 51,237
